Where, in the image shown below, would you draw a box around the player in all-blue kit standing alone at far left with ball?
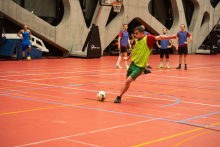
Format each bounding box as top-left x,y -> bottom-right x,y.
18,25 -> 32,60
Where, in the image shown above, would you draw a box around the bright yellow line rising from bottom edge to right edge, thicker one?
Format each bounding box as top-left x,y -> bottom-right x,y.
132,123 -> 220,147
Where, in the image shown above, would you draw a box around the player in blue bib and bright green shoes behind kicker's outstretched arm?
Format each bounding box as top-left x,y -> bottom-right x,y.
156,28 -> 174,69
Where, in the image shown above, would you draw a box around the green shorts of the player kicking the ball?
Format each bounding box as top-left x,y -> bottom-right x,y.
127,61 -> 145,81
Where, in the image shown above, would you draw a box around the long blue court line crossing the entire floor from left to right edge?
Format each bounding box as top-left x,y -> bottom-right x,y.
0,94 -> 220,128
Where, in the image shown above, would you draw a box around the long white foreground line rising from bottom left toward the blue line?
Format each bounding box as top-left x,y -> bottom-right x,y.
15,119 -> 155,147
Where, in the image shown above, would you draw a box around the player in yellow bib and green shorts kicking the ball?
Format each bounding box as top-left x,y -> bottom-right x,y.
114,26 -> 177,103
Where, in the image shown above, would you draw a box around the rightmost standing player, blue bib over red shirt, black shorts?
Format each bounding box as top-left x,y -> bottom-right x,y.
176,24 -> 193,70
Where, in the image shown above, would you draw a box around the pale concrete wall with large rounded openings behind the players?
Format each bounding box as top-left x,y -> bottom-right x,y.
0,0 -> 220,56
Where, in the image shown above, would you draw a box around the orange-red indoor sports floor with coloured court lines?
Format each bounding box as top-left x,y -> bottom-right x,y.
0,54 -> 220,147
